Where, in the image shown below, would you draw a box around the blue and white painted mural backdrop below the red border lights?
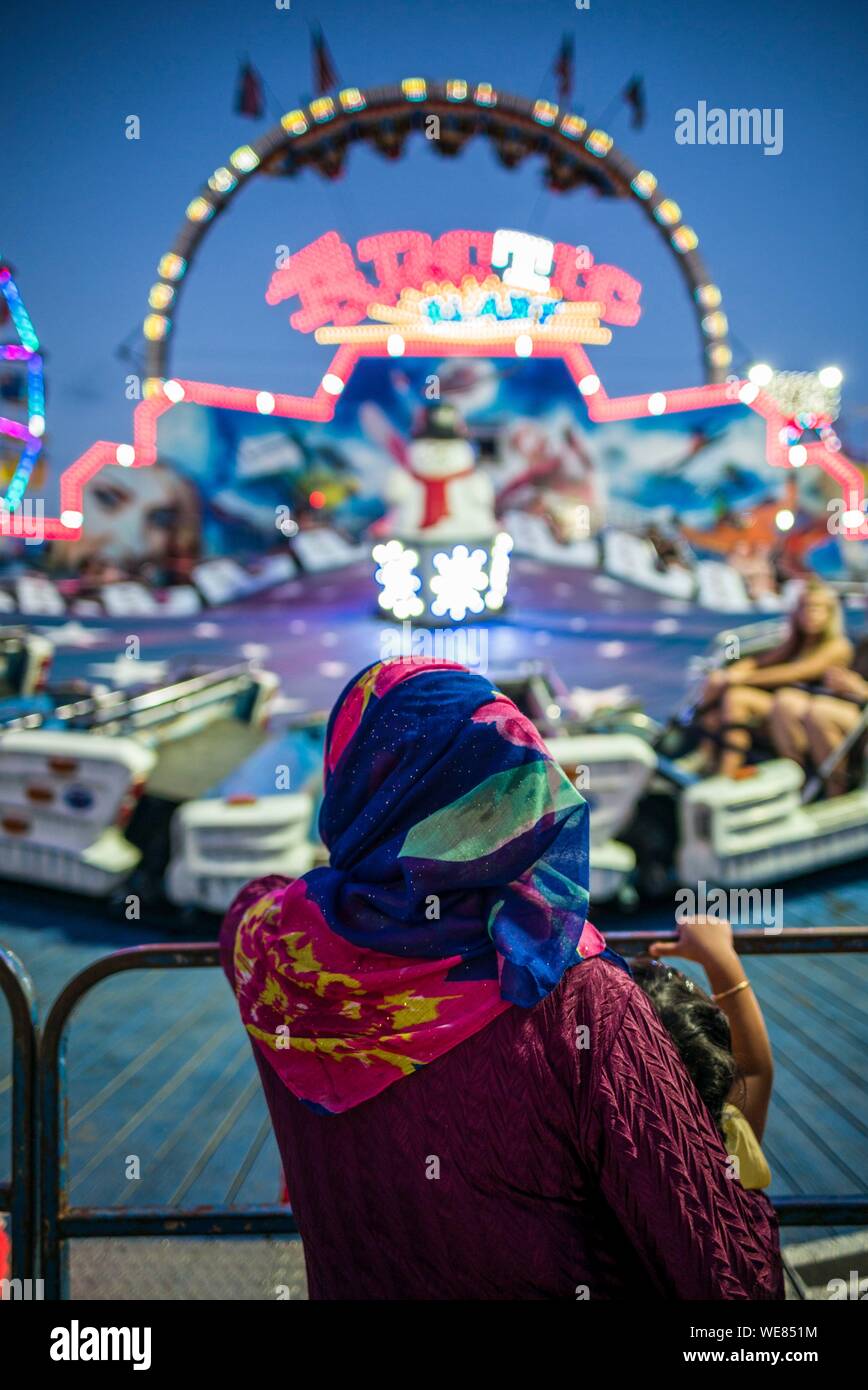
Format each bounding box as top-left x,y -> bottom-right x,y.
137,357 -> 851,574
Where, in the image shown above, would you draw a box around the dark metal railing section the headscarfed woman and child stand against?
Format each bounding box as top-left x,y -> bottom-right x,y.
23,927 -> 868,1298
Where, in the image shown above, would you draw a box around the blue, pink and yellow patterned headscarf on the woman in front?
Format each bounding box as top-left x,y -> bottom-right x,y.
223,659 -> 618,1113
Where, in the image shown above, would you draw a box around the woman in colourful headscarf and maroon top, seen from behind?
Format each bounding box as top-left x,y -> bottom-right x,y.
220,659 -> 783,1301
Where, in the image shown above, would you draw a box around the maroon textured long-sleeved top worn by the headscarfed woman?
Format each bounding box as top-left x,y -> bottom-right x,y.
221,899 -> 783,1300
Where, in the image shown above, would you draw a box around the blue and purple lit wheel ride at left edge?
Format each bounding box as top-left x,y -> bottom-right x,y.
0,257 -> 46,512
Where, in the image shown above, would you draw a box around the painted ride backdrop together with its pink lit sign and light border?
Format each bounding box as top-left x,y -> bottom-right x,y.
11,229 -> 868,602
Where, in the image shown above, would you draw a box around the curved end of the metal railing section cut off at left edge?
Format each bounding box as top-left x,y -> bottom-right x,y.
0,947 -> 36,1279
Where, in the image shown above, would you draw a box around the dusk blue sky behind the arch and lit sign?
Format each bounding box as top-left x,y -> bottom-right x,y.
0,0 -> 868,470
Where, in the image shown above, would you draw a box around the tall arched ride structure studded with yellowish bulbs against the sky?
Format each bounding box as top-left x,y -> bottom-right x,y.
145,78 -> 732,391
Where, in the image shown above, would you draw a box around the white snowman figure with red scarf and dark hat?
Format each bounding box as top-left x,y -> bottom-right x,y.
384,403 -> 498,542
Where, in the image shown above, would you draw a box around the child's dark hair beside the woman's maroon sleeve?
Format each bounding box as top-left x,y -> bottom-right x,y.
630,956 -> 739,1129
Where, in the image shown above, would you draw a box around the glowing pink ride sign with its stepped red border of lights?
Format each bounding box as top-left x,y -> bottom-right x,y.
10,229 -> 868,541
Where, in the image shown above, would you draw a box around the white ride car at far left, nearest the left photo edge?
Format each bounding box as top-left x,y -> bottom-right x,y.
0,638 -> 278,898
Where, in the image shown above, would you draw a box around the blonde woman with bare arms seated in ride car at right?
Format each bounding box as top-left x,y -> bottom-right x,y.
700,580 -> 853,777
